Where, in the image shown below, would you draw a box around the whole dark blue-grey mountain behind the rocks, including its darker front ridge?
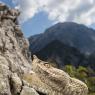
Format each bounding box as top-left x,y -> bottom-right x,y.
29,22 -> 95,68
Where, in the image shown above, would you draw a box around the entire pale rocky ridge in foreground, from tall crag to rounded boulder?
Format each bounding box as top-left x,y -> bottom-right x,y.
0,3 -> 88,95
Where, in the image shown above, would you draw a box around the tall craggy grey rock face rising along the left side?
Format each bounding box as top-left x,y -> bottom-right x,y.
0,3 -> 32,95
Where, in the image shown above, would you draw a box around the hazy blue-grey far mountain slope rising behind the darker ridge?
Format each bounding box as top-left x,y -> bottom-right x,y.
29,22 -> 95,53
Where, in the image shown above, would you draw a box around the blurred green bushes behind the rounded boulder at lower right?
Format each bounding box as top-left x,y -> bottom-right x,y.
63,65 -> 95,95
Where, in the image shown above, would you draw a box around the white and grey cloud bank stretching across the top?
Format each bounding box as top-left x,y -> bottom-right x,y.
13,0 -> 95,25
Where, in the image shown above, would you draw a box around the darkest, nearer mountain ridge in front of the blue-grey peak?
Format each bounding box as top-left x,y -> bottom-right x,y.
35,40 -> 85,68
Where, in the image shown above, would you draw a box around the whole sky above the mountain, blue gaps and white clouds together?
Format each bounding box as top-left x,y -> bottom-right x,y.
0,0 -> 95,37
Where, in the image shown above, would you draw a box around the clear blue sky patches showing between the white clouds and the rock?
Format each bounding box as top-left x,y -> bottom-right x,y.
0,0 -> 52,37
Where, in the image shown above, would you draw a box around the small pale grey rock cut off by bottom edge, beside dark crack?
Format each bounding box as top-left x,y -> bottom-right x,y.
21,86 -> 39,95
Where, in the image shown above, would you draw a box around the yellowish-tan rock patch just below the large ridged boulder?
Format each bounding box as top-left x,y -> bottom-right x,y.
23,72 -> 52,95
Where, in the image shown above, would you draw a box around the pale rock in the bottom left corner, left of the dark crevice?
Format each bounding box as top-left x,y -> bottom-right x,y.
0,60 -> 11,95
